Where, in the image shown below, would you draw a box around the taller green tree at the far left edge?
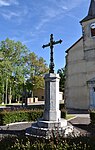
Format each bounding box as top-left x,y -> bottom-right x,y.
0,38 -> 28,103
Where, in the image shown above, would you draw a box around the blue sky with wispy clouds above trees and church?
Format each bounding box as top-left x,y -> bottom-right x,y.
0,0 -> 90,70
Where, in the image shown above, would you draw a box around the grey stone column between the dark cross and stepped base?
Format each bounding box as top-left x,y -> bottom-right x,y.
43,73 -> 60,122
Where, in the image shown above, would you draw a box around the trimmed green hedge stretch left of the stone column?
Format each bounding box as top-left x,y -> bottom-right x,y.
0,110 -> 43,125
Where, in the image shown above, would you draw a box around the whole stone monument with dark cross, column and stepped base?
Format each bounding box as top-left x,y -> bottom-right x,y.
25,34 -> 72,138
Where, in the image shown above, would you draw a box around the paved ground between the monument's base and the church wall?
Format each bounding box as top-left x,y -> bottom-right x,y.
68,110 -> 95,135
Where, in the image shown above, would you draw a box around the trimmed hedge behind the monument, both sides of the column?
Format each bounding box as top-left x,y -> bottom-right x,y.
0,105 -> 67,125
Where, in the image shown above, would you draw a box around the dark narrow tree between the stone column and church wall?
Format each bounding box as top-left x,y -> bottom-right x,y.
57,67 -> 66,92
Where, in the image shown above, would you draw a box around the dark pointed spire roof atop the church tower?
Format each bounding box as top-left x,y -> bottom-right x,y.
80,0 -> 95,23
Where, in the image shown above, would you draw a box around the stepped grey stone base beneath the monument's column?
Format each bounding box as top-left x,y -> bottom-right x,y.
26,119 -> 73,139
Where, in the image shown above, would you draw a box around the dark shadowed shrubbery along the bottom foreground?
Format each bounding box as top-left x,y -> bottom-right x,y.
0,136 -> 95,150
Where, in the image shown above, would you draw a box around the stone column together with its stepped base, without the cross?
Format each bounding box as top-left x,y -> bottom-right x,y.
26,73 -> 73,138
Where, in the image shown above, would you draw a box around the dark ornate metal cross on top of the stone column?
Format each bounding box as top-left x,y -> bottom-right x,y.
42,34 -> 62,73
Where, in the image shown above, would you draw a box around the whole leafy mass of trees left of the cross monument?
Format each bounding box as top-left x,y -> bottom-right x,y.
0,38 -> 48,103
